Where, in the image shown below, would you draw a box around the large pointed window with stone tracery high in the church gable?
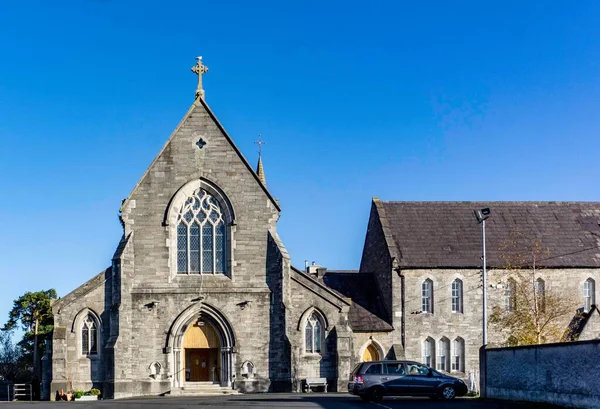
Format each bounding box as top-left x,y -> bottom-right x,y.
177,188 -> 226,274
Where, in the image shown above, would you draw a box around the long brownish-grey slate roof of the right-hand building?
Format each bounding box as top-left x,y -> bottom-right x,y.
373,199 -> 600,268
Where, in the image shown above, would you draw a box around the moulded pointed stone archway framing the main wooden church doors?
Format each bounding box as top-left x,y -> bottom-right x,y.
166,302 -> 235,388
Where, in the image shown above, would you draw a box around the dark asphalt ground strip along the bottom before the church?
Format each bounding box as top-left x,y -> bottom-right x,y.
0,393 -> 564,409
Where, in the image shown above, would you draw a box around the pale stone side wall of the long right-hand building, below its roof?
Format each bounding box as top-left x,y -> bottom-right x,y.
396,268 -> 600,377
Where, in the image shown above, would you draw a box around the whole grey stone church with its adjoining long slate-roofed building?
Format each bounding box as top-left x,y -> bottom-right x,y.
43,62 -> 600,398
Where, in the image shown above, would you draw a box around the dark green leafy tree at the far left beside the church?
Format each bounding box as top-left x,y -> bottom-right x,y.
2,289 -> 57,378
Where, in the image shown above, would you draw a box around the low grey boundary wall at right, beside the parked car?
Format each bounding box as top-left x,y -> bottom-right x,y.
480,339 -> 600,409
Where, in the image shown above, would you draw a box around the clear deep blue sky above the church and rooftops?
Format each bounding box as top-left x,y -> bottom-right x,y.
0,0 -> 600,330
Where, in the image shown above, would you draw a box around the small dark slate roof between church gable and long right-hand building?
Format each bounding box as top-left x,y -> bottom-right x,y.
323,270 -> 394,331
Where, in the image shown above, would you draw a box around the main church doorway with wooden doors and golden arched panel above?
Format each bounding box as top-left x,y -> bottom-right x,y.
183,318 -> 221,382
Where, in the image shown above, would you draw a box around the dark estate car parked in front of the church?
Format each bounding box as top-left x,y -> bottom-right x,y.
348,361 -> 468,402
